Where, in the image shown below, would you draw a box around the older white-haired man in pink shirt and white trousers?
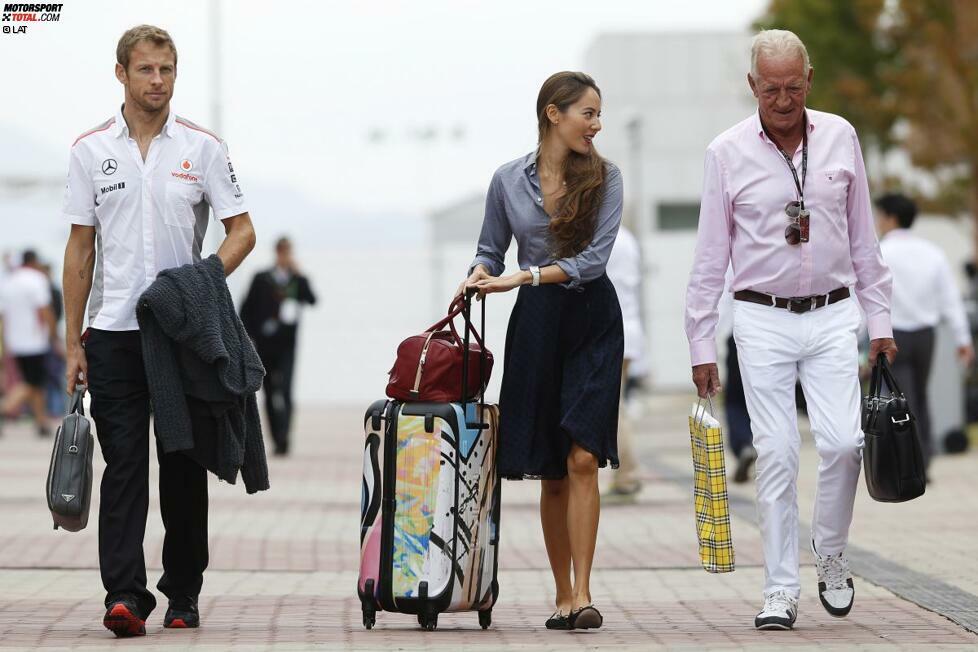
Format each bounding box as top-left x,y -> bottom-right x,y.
686,30 -> 896,629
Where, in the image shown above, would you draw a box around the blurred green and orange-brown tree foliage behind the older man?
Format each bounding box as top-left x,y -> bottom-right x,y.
756,0 -> 978,250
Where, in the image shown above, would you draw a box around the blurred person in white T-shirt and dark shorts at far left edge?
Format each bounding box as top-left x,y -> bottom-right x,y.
0,249 -> 57,437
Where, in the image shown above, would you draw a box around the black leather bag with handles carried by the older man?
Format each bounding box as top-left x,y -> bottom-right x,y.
862,354 -> 926,503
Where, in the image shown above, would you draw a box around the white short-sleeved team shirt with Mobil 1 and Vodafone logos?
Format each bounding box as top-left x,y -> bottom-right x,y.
62,107 -> 248,331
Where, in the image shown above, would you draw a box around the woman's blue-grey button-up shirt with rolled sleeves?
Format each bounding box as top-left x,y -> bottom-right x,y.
469,151 -> 622,289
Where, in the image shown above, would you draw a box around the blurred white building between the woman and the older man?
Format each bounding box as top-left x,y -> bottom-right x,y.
584,33 -> 756,389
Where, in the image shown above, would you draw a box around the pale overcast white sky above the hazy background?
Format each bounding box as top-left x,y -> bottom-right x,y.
0,0 -> 766,216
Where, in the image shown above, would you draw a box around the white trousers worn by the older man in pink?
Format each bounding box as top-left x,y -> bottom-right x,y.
733,298 -> 863,598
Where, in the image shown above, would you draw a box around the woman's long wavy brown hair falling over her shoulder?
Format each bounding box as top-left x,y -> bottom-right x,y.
537,71 -> 605,258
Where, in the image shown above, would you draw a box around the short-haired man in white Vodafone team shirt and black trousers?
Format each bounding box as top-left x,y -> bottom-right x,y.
63,25 -> 255,636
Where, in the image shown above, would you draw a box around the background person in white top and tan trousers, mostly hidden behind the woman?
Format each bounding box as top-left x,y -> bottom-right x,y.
605,225 -> 645,502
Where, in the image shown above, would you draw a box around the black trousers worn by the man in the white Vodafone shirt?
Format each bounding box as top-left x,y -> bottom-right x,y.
85,329 -> 217,618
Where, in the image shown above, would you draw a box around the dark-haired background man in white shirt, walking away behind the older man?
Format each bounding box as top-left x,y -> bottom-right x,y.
876,193 -> 975,481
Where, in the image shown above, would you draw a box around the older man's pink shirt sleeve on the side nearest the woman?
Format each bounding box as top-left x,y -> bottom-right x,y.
686,149 -> 733,367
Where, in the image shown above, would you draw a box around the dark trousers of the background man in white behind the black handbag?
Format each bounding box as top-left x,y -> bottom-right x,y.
892,328 -> 934,468
